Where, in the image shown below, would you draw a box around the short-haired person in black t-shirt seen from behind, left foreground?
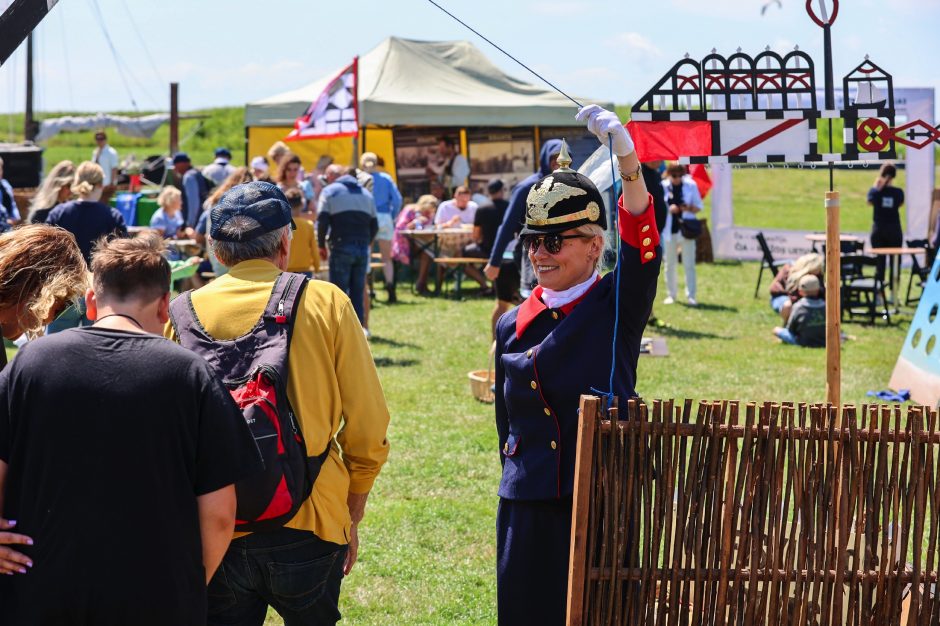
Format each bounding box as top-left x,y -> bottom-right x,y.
0,236 -> 261,626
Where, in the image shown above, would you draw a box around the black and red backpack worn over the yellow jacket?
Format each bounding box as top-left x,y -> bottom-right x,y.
170,272 -> 330,532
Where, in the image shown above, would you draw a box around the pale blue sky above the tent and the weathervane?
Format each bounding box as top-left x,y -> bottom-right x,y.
0,0 -> 940,112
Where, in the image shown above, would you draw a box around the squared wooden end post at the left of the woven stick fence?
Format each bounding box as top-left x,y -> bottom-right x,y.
566,395 -> 601,626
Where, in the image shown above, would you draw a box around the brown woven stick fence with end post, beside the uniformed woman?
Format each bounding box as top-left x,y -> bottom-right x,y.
568,396 -> 940,626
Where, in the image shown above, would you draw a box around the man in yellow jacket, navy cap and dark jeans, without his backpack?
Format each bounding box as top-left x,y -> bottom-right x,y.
166,181 -> 389,626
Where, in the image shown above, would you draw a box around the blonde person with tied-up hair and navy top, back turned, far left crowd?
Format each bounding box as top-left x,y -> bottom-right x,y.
46,161 -> 127,264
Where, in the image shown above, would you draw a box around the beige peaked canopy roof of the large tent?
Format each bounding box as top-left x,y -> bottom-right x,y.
245,37 -> 613,126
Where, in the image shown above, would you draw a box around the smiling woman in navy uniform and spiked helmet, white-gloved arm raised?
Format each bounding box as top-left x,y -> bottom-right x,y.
496,105 -> 661,626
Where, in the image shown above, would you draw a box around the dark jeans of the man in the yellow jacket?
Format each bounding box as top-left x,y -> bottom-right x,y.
207,528 -> 347,626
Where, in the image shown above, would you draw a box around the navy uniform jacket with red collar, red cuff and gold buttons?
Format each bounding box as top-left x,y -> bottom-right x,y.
496,197 -> 661,500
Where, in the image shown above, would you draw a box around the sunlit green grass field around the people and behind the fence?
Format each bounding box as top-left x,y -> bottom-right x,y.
0,109 -> 913,625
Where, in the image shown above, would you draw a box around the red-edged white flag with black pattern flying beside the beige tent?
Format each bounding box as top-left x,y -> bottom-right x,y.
286,57 -> 359,141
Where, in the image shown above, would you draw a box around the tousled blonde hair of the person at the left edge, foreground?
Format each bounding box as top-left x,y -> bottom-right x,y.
0,224 -> 88,337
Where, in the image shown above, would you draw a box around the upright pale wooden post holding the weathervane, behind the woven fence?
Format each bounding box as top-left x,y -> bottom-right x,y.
826,191 -> 842,409
